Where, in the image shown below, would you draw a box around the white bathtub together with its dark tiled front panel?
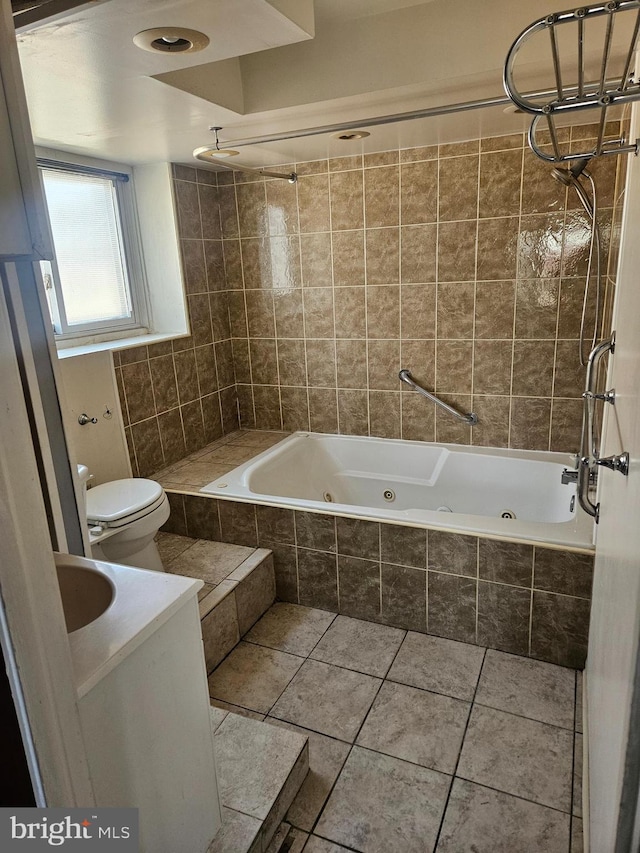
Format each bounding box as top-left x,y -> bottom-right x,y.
160,432 -> 593,668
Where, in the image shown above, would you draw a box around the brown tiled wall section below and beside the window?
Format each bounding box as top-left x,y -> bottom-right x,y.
114,166 -> 238,477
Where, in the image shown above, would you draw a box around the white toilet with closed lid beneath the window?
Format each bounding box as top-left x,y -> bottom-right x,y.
78,465 -> 170,572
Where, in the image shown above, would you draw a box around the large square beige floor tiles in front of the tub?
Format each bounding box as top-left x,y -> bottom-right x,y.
209,603 -> 582,853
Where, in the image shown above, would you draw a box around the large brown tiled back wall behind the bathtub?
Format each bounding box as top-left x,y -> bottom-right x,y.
222,125 -> 624,451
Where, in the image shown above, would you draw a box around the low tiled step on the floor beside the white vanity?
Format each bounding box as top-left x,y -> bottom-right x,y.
209,708 -> 309,853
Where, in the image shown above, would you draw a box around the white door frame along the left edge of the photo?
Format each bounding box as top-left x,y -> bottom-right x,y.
0,0 -> 95,808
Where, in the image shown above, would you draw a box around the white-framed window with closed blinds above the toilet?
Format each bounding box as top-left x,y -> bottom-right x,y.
38,160 -> 146,338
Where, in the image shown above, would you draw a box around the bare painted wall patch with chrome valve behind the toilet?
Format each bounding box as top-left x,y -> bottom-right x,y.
58,352 -> 131,485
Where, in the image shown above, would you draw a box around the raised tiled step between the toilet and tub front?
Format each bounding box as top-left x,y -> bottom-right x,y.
158,533 -> 276,672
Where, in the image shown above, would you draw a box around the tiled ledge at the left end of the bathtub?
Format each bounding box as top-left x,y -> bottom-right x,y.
153,430 -> 289,492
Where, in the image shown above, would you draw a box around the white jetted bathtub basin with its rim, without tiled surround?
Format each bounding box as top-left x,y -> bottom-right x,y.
200,432 -> 593,550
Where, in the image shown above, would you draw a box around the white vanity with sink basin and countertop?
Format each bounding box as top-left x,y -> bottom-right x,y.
56,554 -> 221,853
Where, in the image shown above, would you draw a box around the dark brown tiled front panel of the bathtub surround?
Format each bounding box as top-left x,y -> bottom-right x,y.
164,494 -> 593,668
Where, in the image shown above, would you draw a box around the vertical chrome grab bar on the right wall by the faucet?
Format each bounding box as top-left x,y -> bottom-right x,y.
577,332 -> 629,523
